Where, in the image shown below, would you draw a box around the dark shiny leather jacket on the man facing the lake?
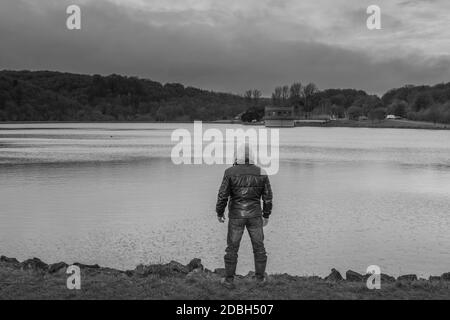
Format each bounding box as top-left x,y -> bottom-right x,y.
216,164 -> 272,219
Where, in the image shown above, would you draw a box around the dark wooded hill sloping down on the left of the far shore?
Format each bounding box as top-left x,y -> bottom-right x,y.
0,71 -> 249,121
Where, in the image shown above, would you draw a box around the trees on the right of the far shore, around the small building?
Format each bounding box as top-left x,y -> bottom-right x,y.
244,82 -> 450,123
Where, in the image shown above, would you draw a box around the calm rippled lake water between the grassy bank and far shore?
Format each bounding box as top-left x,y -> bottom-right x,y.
0,124 -> 450,276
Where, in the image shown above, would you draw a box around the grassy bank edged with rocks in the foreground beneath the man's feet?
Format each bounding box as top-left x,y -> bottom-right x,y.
0,257 -> 450,300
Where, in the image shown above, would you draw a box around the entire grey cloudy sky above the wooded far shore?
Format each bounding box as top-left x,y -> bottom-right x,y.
0,0 -> 450,96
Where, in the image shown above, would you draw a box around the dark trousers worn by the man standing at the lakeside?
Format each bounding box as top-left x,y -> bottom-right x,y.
224,217 -> 267,280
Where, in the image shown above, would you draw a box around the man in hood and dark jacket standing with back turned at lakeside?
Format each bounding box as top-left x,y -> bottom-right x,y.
216,144 -> 272,288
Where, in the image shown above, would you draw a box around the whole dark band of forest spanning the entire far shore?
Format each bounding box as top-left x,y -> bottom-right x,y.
0,70 -> 450,123
